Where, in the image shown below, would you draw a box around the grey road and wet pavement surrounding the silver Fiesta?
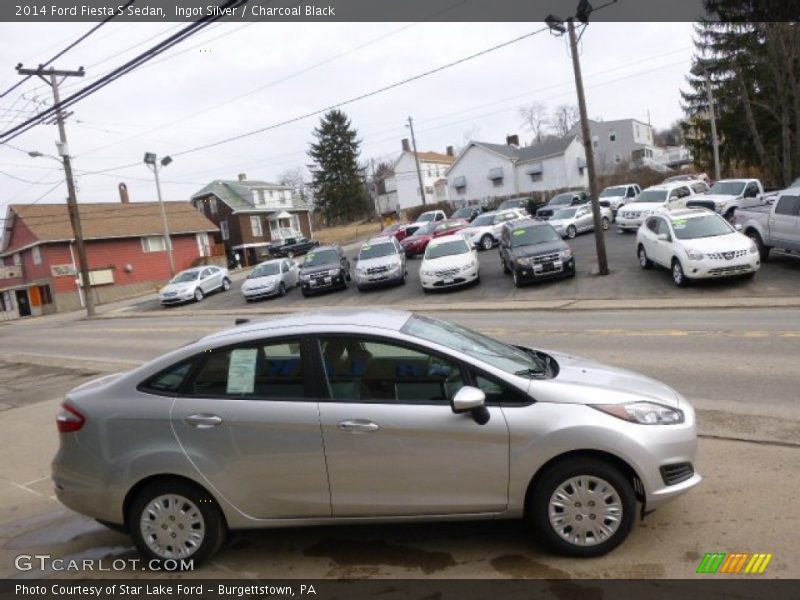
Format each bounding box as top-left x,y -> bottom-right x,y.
0,309 -> 800,578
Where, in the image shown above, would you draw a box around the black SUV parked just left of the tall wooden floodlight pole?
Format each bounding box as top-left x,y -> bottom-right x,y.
500,219 -> 575,287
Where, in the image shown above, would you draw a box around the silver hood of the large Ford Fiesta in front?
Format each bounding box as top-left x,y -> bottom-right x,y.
531,350 -> 681,408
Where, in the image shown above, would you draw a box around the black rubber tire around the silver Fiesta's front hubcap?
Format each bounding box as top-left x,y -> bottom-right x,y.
527,457 -> 636,558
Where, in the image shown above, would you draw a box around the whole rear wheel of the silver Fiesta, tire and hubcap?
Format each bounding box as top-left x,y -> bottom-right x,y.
128,479 -> 226,568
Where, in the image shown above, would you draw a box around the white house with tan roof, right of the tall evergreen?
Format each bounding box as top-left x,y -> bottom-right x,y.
376,139 -> 455,214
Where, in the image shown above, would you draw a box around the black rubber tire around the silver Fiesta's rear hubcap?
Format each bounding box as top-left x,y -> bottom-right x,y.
127,479 -> 227,567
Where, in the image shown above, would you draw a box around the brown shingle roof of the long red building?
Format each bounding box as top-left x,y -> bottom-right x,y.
6,201 -> 217,251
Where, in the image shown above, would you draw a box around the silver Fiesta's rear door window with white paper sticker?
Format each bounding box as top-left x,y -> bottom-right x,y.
187,340 -> 305,400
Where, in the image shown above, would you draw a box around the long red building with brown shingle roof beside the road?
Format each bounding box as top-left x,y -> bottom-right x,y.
0,201 -> 217,320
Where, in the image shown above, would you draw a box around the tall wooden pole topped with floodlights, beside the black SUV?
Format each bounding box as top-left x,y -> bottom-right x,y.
544,0 -> 608,275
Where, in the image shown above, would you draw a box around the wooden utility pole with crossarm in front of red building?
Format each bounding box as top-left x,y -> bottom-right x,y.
17,64 -> 95,317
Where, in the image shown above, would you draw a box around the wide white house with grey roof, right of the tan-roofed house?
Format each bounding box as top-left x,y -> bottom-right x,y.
447,134 -> 589,203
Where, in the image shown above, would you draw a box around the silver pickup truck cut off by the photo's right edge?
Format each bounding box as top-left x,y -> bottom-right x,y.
734,187 -> 800,260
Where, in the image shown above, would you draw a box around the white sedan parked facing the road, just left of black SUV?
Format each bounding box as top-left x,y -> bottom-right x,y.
419,232 -> 481,293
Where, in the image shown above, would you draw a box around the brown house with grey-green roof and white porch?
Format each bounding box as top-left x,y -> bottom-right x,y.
192,173 -> 311,266
